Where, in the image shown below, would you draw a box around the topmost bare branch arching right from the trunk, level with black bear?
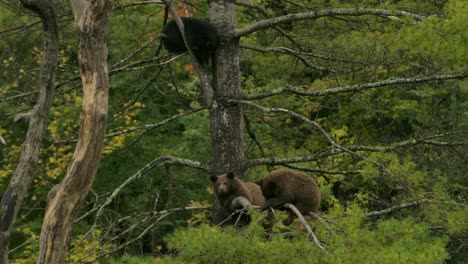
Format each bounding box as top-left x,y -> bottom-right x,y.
235,8 -> 426,38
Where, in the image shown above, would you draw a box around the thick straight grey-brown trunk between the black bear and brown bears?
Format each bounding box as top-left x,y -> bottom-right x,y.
210,0 -> 247,224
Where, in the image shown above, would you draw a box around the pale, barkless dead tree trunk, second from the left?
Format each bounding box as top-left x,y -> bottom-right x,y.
37,0 -> 112,264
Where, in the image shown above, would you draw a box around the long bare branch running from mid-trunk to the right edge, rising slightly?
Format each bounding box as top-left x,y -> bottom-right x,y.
247,73 -> 468,100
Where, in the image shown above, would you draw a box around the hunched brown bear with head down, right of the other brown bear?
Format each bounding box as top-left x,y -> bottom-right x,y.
257,170 -> 320,225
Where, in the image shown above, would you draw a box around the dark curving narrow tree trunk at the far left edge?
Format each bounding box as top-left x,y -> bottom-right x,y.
0,0 -> 58,264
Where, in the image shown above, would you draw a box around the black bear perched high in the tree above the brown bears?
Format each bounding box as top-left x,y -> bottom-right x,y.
161,17 -> 218,65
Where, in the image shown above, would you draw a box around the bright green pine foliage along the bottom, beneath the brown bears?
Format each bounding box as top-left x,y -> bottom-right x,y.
155,207 -> 448,263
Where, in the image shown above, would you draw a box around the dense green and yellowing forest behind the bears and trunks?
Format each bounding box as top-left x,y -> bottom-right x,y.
0,0 -> 468,263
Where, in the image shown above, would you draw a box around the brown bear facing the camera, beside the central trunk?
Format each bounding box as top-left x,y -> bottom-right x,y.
211,172 -> 265,213
